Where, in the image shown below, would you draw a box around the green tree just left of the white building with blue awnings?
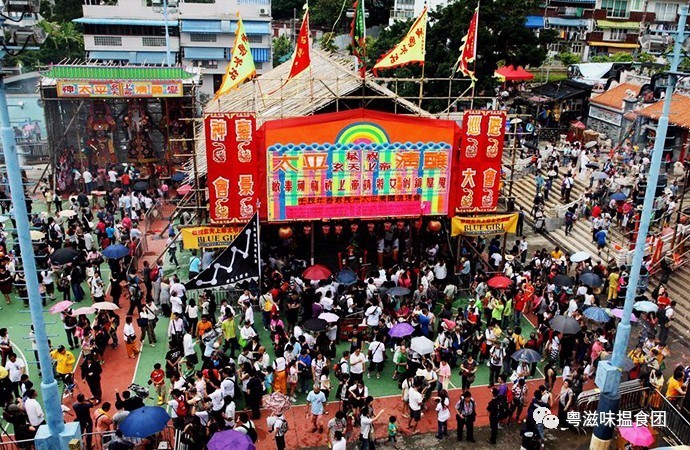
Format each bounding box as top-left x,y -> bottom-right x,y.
7,20 -> 84,71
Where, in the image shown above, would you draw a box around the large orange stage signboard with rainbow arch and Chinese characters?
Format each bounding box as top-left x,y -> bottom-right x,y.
265,110 -> 456,221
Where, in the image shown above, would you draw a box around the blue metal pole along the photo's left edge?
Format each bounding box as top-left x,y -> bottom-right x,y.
0,72 -> 65,449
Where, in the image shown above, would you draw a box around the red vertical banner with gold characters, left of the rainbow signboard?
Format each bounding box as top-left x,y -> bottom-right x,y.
204,113 -> 261,223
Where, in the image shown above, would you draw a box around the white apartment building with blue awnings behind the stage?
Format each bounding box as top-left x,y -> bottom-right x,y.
75,0 -> 273,95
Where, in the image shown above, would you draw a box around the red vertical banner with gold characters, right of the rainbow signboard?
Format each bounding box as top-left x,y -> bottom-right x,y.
453,110 -> 506,213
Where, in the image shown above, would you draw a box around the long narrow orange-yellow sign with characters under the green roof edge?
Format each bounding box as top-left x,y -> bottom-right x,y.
57,81 -> 183,98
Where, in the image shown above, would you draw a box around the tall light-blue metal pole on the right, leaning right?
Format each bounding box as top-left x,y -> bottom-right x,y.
590,6 -> 688,449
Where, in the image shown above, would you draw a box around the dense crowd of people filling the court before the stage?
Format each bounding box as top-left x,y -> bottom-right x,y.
0,136 -> 690,450
